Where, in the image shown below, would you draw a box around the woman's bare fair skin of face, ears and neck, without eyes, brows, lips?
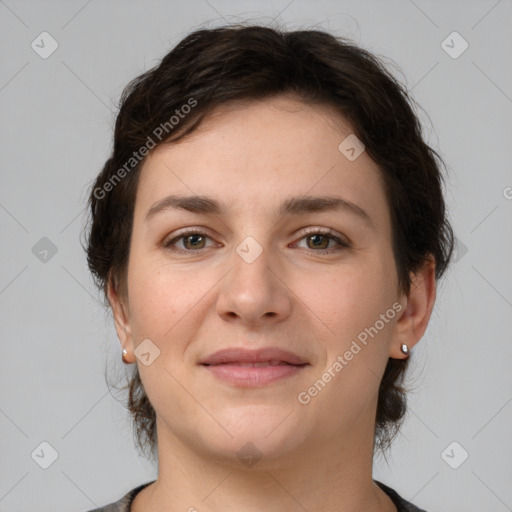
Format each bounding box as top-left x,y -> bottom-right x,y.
108,96 -> 436,512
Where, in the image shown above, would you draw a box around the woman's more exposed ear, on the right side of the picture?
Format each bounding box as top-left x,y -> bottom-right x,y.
389,257 -> 436,359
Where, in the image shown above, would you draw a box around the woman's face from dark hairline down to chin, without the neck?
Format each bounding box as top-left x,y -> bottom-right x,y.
112,97 -> 412,468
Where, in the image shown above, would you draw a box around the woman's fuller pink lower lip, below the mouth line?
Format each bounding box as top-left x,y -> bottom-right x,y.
204,364 -> 305,388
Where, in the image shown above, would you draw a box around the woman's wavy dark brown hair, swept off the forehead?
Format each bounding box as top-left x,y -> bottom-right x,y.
86,24 -> 453,455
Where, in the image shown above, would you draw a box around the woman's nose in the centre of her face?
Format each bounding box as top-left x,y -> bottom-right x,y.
217,243 -> 293,326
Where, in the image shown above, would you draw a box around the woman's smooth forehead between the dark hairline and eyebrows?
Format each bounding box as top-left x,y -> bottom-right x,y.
136,97 -> 387,230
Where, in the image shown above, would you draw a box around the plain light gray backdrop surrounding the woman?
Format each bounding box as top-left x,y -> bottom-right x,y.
0,0 -> 512,512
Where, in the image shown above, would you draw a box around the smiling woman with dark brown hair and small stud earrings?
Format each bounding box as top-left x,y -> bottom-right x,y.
87,25 -> 453,512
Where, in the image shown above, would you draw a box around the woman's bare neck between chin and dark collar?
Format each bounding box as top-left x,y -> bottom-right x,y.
131,416 -> 396,512
